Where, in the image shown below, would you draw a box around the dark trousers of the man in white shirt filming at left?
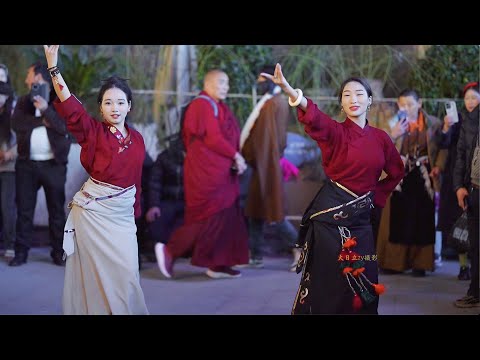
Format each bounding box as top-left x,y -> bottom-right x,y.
15,160 -> 67,255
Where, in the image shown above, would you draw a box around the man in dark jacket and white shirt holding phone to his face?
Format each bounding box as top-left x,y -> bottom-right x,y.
9,62 -> 71,266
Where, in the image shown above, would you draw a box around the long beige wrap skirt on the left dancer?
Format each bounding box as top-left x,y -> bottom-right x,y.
63,178 -> 148,315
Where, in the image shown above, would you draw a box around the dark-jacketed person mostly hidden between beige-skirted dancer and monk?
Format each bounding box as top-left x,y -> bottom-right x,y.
145,136 -> 185,244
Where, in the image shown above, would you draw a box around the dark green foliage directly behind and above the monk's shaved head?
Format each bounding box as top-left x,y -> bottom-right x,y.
197,45 -> 275,124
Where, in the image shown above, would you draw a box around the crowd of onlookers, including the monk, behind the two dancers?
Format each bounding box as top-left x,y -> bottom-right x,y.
0,62 -> 480,307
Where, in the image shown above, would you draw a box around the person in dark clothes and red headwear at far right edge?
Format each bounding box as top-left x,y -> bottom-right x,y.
453,82 -> 480,308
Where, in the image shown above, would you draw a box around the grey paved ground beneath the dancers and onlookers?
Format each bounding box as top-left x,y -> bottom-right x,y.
0,247 -> 480,315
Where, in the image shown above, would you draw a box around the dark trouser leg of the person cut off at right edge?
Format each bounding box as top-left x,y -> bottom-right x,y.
467,188 -> 480,299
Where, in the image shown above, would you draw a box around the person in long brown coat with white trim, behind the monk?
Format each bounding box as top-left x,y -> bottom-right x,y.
240,66 -> 300,271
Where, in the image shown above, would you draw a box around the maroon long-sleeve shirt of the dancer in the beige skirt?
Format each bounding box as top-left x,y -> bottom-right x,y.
54,96 -> 145,218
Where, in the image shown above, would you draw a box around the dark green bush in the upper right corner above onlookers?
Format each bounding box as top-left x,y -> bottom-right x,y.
409,45 -> 480,113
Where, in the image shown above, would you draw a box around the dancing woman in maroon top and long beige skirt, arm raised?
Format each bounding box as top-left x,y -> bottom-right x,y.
44,45 -> 148,315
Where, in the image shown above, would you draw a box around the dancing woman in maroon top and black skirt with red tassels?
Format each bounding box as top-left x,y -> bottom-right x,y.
261,64 -> 404,314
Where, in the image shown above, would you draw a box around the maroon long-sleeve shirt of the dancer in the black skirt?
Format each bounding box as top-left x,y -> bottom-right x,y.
297,99 -> 404,207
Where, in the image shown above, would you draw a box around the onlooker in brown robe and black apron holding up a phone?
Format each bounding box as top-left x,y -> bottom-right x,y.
377,89 -> 447,277
